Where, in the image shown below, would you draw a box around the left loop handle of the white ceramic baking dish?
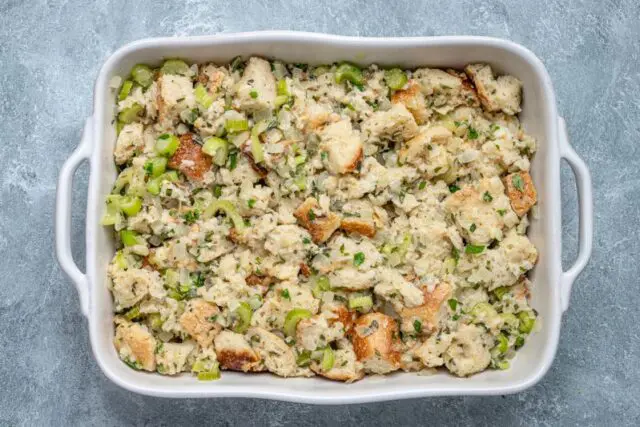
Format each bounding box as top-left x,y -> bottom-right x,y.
56,118 -> 93,316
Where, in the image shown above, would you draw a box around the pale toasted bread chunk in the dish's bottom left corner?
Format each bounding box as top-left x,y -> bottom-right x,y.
113,320 -> 156,371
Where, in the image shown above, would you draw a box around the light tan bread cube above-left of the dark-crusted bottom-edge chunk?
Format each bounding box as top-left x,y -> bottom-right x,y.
180,298 -> 222,347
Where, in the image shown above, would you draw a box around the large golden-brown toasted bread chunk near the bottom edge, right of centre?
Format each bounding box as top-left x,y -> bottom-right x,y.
351,312 -> 400,374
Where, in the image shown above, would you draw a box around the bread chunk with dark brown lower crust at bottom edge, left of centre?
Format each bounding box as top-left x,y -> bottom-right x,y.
214,330 -> 262,372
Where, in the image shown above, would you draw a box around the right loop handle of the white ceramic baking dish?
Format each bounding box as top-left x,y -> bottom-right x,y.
558,117 -> 593,311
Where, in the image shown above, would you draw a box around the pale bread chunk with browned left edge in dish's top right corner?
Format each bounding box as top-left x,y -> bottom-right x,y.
464,64 -> 522,115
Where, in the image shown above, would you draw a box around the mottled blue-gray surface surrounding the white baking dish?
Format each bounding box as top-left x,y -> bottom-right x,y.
0,0 -> 640,426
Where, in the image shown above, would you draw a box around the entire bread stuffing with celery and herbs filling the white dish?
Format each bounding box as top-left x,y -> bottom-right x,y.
107,56 -> 538,382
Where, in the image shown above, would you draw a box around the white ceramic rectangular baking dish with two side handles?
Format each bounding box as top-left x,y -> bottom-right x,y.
56,31 -> 593,404
